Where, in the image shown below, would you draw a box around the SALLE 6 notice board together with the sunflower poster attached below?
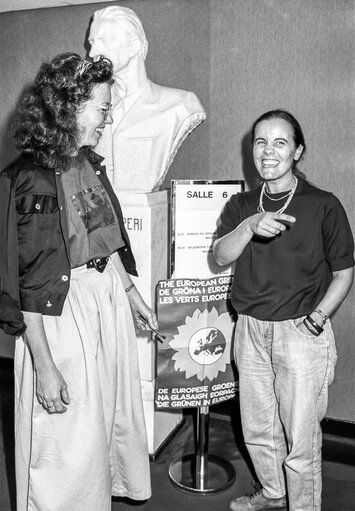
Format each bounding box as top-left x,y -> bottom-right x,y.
155,180 -> 244,410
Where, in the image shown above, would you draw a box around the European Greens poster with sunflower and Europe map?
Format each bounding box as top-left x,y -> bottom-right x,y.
155,275 -> 238,409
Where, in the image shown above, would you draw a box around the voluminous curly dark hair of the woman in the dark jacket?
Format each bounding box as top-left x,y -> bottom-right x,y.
12,53 -> 113,170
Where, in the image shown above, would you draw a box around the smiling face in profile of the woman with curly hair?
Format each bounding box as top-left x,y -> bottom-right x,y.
76,83 -> 112,147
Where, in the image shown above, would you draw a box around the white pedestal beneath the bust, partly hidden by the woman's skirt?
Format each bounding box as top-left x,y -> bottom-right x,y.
116,190 -> 182,454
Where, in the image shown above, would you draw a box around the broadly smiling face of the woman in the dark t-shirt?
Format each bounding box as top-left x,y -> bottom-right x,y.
253,118 -> 303,187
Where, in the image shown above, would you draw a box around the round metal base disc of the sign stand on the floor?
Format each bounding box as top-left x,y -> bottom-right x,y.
169,454 -> 235,495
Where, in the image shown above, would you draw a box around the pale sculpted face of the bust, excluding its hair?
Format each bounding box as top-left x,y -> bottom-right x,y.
89,19 -> 134,73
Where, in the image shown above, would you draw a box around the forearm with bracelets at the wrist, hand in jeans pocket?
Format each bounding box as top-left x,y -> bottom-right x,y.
297,267 -> 354,335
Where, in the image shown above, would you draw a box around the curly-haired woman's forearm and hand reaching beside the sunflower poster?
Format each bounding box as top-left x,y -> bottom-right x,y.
111,252 -> 158,330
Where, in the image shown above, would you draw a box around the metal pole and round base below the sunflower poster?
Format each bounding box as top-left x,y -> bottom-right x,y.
169,406 -> 235,495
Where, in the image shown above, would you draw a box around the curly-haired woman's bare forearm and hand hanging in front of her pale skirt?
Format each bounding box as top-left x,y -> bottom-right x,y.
23,312 -> 70,413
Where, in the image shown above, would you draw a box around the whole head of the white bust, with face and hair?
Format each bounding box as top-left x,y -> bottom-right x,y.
89,6 -> 148,73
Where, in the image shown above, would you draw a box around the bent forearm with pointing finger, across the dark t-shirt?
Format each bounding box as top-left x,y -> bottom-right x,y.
213,212 -> 296,266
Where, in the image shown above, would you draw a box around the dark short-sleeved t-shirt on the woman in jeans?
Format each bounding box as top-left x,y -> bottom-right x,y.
217,179 -> 354,321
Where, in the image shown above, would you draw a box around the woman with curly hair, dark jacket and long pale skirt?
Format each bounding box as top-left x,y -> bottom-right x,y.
0,53 -> 157,511
